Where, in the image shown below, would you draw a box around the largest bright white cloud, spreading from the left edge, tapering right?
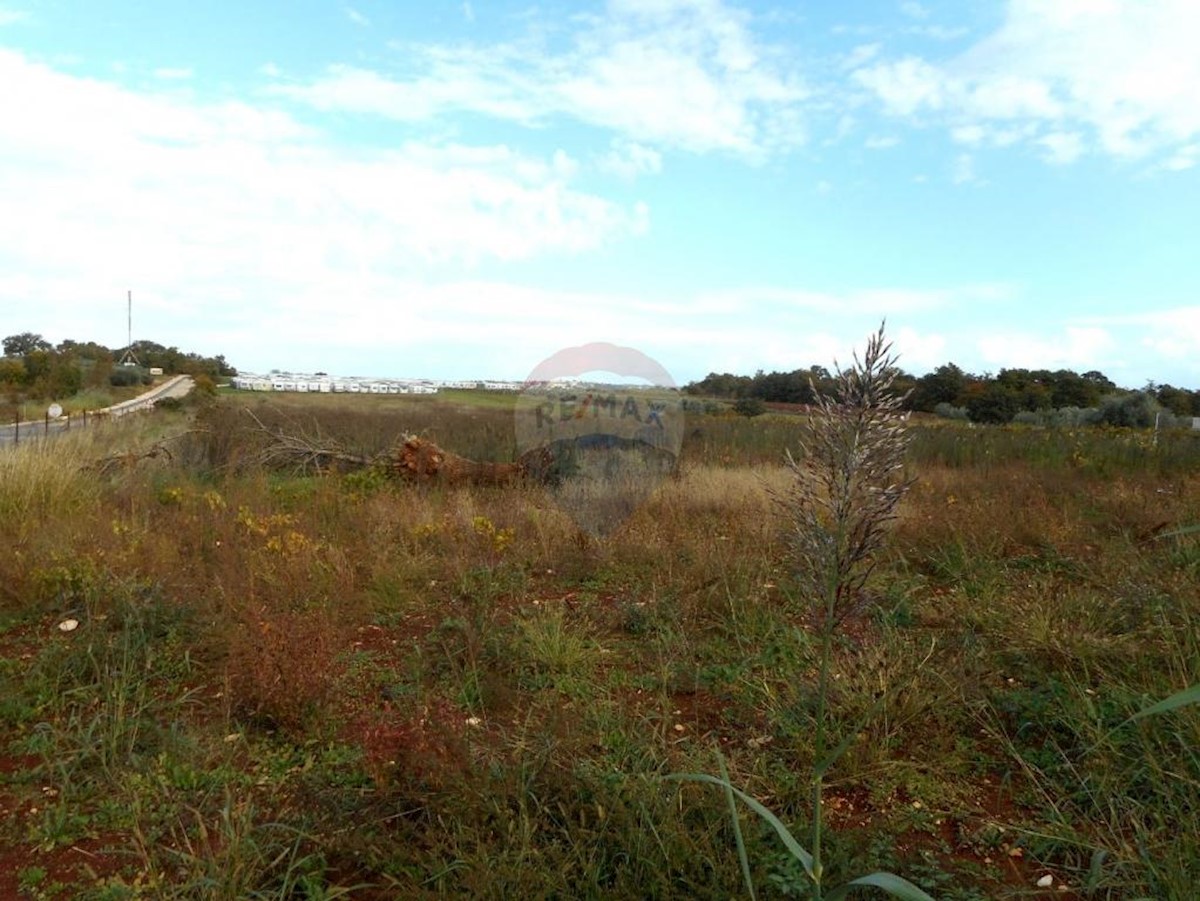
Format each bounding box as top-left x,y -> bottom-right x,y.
0,50 -> 649,347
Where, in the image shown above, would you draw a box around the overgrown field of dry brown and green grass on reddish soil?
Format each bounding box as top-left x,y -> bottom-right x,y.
0,392 -> 1200,899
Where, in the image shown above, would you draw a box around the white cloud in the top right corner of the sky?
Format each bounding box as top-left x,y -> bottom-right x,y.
854,0 -> 1200,163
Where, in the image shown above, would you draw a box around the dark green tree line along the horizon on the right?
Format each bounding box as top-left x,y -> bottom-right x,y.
684,362 -> 1200,426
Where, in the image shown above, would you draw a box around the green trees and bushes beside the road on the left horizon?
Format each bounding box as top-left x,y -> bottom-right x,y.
0,331 -> 238,401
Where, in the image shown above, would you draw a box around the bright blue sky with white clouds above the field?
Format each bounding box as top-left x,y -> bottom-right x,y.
0,0 -> 1200,388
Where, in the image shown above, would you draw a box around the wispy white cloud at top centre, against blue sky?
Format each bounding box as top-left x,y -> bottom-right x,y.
276,0 -> 810,157
